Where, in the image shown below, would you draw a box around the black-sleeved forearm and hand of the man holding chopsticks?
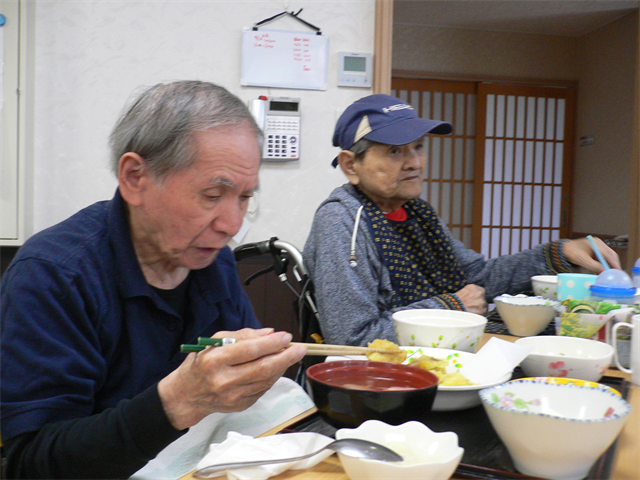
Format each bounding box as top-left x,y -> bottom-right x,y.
5,329 -> 305,480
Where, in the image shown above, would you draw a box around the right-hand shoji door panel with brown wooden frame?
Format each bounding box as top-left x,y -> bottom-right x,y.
473,84 -> 575,258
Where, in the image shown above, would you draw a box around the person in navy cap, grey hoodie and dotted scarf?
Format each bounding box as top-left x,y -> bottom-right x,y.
303,94 -> 619,345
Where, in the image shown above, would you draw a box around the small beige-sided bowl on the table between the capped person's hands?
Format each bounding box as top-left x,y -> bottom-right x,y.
493,295 -> 558,337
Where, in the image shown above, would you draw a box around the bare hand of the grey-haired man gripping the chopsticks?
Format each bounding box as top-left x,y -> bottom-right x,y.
158,328 -> 306,430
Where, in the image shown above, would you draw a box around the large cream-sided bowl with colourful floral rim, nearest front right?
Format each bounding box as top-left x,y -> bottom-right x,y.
480,377 -> 631,480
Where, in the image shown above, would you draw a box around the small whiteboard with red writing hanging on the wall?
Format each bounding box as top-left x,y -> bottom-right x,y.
240,29 -> 329,90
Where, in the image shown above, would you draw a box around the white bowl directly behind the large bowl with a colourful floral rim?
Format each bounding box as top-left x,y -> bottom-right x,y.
516,335 -> 614,382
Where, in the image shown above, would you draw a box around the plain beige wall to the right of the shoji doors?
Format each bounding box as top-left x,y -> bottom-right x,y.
573,12 -> 638,239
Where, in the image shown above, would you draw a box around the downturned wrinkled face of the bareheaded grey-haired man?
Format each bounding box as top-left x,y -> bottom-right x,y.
138,126 -> 260,270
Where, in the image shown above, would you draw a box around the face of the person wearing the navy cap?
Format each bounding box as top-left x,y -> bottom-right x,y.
349,138 -> 427,212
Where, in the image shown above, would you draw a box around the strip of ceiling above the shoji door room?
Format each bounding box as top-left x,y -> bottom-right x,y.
393,0 -> 638,37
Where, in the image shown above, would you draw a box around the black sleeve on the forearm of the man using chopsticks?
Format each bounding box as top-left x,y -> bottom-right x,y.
4,385 -> 186,480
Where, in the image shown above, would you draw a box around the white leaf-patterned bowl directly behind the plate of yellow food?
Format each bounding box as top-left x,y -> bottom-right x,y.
392,309 -> 487,352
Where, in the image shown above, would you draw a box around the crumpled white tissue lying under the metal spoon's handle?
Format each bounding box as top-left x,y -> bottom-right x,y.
196,432 -> 333,480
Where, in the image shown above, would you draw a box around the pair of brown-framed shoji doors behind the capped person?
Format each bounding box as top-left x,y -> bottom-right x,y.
391,78 -> 575,258
